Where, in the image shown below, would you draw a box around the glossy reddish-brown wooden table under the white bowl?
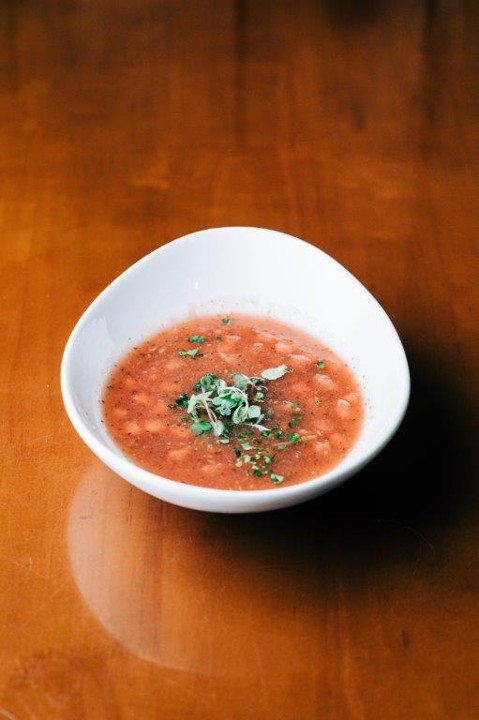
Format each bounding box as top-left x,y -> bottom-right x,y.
0,0 -> 479,720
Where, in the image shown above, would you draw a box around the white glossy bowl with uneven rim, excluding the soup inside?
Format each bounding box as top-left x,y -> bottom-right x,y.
61,227 -> 410,513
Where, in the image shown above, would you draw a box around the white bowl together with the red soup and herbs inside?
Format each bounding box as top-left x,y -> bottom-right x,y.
61,227 -> 409,513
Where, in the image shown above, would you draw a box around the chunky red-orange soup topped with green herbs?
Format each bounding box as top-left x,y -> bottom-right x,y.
102,314 -> 364,490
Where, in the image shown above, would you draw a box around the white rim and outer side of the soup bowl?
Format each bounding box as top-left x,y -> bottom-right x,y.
60,225 -> 411,512
